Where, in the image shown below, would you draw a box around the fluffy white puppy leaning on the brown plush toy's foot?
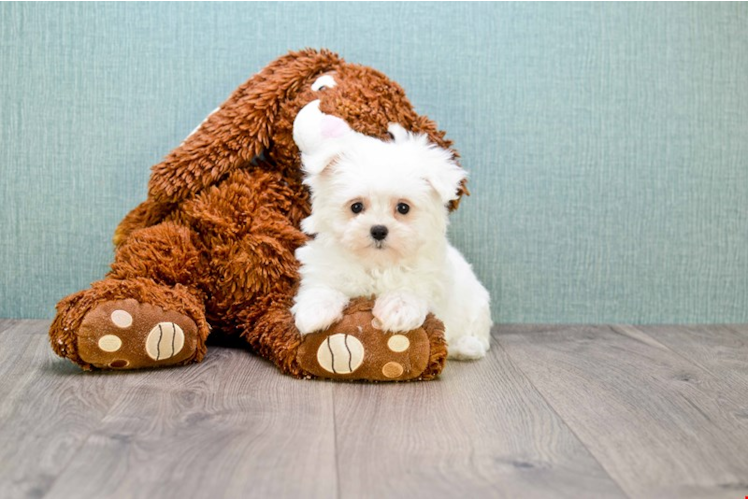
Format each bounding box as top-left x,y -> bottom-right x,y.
292,101 -> 491,359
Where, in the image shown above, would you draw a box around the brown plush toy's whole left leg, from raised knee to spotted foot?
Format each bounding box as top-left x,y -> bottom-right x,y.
50,222 -> 209,369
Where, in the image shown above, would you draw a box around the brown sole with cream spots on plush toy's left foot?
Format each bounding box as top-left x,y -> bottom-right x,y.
78,299 -> 198,369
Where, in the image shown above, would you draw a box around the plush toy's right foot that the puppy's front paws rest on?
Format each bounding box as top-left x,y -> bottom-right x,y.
296,299 -> 447,381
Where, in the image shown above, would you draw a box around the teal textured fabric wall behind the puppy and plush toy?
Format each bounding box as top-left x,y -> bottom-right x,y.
0,2 -> 748,323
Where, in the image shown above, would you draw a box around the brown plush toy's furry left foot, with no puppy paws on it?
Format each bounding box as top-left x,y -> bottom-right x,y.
49,278 -> 210,370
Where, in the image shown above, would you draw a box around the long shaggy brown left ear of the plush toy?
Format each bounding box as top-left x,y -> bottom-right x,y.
148,49 -> 343,203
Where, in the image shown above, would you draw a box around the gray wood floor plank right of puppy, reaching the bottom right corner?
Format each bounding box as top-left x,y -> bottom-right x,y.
494,325 -> 748,498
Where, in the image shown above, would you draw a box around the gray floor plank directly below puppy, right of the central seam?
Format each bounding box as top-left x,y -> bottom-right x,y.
334,338 -> 624,498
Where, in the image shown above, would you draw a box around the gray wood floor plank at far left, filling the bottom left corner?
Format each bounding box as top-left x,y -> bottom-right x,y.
0,320 -> 137,498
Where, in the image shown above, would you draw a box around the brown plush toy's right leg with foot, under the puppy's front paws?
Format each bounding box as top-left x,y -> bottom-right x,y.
224,220 -> 447,381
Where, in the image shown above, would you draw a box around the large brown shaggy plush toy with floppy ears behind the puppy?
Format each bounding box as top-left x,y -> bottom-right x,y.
50,49 -> 467,380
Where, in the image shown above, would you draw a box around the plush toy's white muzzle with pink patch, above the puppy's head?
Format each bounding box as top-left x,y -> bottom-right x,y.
293,100 -> 355,176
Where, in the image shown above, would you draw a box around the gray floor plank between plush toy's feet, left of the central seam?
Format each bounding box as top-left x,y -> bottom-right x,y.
45,347 -> 337,499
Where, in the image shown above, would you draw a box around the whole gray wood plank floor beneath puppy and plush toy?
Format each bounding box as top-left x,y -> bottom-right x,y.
0,320 -> 748,499
